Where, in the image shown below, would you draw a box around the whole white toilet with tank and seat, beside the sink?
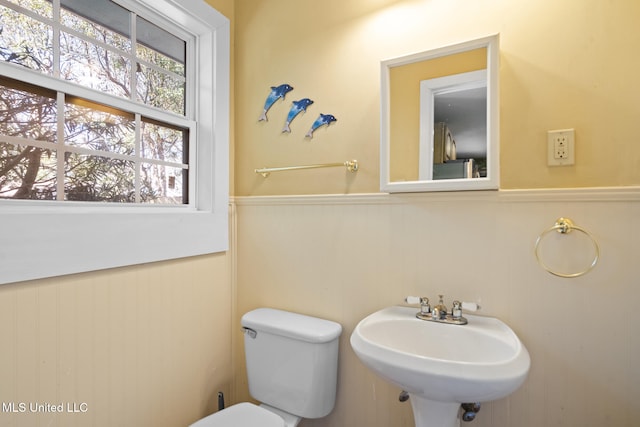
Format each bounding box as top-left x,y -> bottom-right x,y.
191,308 -> 342,427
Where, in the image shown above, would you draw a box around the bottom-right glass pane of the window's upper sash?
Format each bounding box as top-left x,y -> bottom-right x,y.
137,64 -> 185,115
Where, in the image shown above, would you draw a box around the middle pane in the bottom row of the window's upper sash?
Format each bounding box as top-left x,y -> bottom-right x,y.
60,32 -> 131,98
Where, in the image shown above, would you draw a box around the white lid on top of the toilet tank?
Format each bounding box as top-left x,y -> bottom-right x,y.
241,308 -> 342,343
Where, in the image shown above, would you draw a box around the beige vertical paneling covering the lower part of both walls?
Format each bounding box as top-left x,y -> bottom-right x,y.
0,196 -> 640,427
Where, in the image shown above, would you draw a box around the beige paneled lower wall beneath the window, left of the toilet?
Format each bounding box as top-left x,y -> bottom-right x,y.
0,254 -> 232,427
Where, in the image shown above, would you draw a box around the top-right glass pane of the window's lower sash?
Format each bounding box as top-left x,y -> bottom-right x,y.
141,121 -> 187,163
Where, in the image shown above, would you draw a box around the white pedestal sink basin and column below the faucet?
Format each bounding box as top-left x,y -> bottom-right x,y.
351,307 -> 531,427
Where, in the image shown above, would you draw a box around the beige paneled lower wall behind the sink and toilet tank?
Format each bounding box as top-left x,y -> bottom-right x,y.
233,191 -> 640,427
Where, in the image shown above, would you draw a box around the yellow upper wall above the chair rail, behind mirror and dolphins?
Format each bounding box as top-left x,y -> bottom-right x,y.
235,0 -> 640,195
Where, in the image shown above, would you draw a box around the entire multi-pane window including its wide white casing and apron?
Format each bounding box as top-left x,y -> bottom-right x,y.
0,0 -> 229,283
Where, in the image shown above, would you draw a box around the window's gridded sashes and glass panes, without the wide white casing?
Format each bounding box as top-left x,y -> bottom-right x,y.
0,0 -> 194,204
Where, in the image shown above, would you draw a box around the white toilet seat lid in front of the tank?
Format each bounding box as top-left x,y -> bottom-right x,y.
190,402 -> 284,427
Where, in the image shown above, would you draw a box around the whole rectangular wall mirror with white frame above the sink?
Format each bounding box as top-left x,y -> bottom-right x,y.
380,35 -> 499,193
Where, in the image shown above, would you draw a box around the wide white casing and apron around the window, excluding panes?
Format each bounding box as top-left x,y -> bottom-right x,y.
0,0 -> 230,284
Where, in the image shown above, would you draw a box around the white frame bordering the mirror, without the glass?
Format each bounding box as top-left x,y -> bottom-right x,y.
380,34 -> 500,193
